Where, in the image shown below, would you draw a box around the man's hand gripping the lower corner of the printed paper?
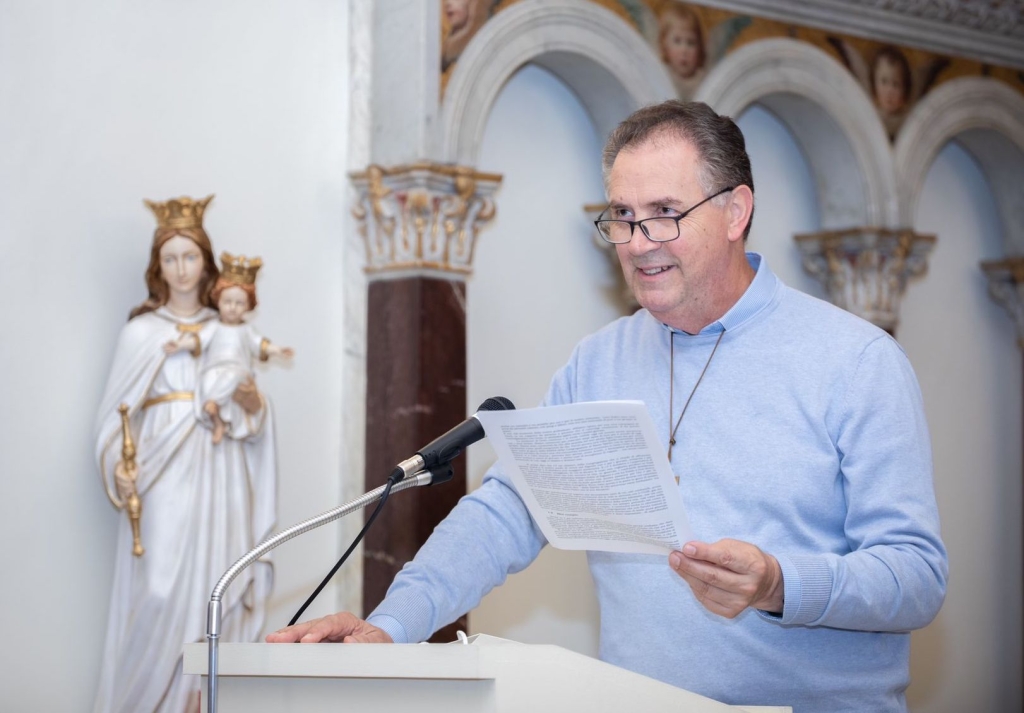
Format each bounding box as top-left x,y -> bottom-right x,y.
669,540 -> 784,619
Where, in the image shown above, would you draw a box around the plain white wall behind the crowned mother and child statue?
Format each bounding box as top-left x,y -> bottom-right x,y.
0,0 -> 350,711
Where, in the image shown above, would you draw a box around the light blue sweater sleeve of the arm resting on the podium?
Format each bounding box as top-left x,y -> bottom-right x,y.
367,354 -> 575,643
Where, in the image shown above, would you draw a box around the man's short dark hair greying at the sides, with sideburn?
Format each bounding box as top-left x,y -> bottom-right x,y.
601,99 -> 754,240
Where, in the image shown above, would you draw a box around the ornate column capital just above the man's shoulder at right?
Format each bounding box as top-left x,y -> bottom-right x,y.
796,227 -> 935,333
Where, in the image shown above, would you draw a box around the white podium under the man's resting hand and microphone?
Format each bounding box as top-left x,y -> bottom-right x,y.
184,634 -> 792,713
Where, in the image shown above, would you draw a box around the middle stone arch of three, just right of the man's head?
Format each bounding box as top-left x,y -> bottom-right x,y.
694,39 -> 898,228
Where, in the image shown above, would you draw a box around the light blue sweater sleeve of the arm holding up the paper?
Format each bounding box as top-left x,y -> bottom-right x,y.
775,336 -> 948,631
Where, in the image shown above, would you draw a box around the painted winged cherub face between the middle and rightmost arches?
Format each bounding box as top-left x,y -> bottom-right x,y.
827,37 -> 949,140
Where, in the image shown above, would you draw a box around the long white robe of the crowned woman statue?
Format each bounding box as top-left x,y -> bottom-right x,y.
95,307 -> 276,713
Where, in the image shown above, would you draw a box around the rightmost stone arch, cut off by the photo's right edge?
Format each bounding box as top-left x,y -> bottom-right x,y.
895,77 -> 1024,255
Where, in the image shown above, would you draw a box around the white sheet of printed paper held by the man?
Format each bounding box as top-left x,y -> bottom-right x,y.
476,402 -> 693,554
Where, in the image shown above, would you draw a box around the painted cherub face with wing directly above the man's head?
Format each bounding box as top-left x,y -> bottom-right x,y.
657,2 -> 751,99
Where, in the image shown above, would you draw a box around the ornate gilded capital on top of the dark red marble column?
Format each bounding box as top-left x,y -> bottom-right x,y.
349,162 -> 502,280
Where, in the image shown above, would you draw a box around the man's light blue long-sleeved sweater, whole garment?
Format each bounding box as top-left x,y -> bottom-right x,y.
369,253 -> 948,712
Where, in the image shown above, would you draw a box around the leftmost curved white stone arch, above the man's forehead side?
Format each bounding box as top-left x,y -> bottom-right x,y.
438,0 -> 675,166
